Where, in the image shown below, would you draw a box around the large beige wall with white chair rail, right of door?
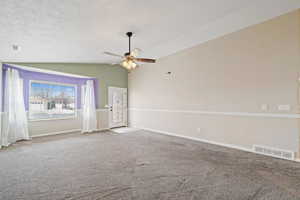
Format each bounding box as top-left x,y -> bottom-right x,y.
128,11 -> 300,158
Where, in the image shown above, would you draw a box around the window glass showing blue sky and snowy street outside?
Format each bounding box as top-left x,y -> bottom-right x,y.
29,81 -> 76,120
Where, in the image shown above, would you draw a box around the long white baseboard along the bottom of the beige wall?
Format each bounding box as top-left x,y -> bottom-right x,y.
133,127 -> 300,162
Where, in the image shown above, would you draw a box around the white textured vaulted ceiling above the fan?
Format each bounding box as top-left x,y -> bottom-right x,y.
0,0 -> 300,63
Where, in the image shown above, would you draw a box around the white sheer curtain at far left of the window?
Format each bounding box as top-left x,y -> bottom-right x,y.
0,69 -> 30,148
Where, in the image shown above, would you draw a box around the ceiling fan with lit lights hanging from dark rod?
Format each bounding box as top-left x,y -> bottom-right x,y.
104,32 -> 156,71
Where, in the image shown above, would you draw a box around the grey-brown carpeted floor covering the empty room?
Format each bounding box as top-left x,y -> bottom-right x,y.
0,131 -> 300,200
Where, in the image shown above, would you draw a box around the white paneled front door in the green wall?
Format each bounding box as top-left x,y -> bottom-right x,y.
108,87 -> 127,128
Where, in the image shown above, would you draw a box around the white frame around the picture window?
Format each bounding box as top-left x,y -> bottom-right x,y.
28,80 -> 78,122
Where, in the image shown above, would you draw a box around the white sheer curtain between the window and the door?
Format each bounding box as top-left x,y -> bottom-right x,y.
82,80 -> 97,133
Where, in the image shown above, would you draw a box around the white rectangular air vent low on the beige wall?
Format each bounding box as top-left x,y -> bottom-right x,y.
253,145 -> 295,160
